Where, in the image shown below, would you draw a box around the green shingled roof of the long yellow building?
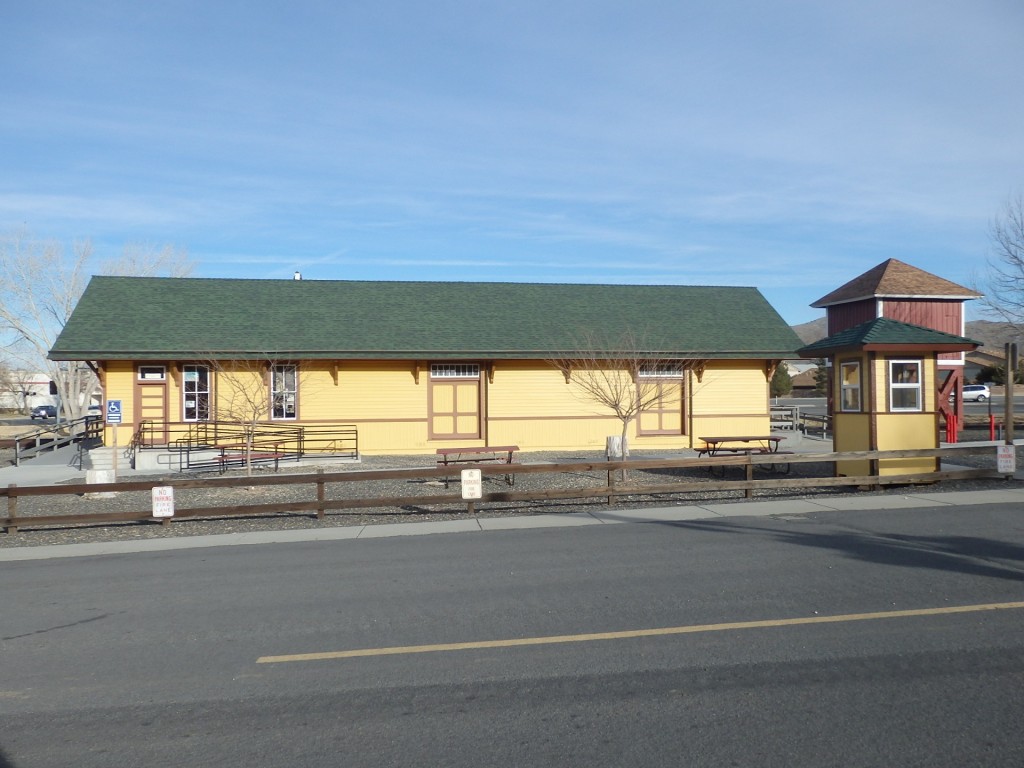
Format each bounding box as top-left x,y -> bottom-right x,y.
50,278 -> 801,360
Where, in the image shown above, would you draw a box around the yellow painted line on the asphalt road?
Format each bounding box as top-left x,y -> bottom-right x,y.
256,602 -> 1024,664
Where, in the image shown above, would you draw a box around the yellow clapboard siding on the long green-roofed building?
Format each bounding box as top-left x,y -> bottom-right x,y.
97,360 -> 768,454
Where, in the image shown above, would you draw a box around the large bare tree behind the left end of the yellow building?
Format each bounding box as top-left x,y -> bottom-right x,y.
0,231 -> 191,419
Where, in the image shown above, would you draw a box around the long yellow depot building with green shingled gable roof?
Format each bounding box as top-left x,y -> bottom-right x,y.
49,276 -> 801,454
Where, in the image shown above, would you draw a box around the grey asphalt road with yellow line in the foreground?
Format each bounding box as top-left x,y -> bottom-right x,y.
0,505 -> 1024,768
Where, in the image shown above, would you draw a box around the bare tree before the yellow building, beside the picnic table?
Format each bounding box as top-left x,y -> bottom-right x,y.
549,331 -> 703,459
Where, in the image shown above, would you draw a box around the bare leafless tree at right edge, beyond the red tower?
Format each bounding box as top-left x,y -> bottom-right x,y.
980,194 -> 1024,329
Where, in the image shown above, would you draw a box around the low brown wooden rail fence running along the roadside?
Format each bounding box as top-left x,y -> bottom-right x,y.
0,445 -> 1004,534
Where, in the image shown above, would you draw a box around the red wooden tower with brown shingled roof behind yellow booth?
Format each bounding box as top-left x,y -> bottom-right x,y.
811,259 -> 982,441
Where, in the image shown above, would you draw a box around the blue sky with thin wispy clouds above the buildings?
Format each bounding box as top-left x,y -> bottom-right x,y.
0,0 -> 1024,324
